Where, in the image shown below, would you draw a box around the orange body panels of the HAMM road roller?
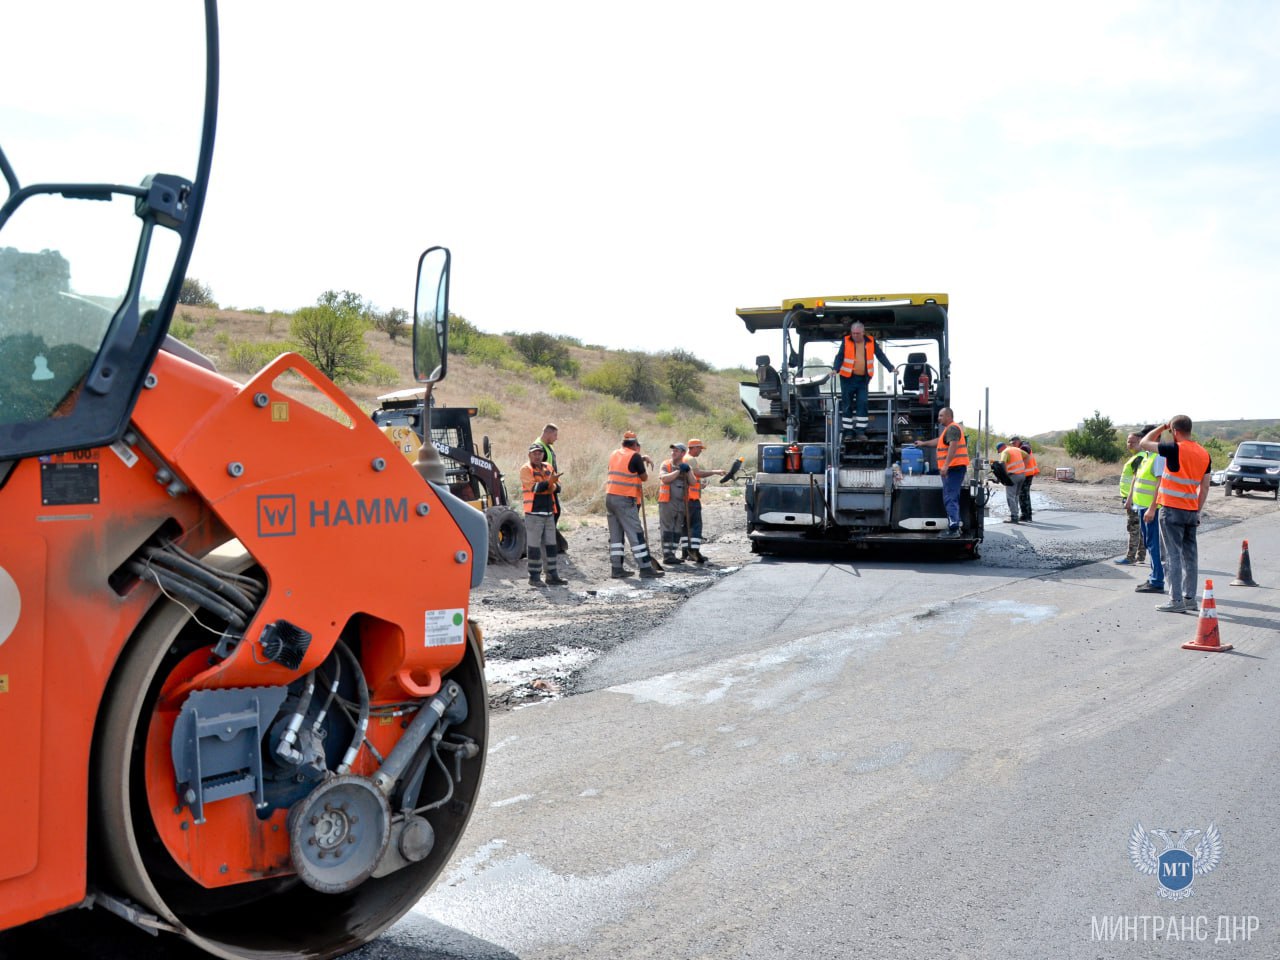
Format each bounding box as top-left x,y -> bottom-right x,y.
0,353 -> 474,928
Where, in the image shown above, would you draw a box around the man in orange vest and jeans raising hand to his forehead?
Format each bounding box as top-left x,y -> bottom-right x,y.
1138,413 -> 1212,613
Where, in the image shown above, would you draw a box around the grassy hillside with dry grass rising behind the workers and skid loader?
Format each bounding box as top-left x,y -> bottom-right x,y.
173,306 -> 755,512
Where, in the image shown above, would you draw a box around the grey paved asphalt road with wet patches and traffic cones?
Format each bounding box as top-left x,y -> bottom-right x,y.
373,513 -> 1280,960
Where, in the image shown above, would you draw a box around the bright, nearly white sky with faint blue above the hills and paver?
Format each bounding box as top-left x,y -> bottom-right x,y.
0,0 -> 1280,433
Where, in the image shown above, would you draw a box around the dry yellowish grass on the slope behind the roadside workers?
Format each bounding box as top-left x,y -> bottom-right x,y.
166,306 -> 755,513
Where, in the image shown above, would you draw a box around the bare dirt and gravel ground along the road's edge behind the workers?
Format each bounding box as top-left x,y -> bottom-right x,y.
471,475 -> 1280,710
